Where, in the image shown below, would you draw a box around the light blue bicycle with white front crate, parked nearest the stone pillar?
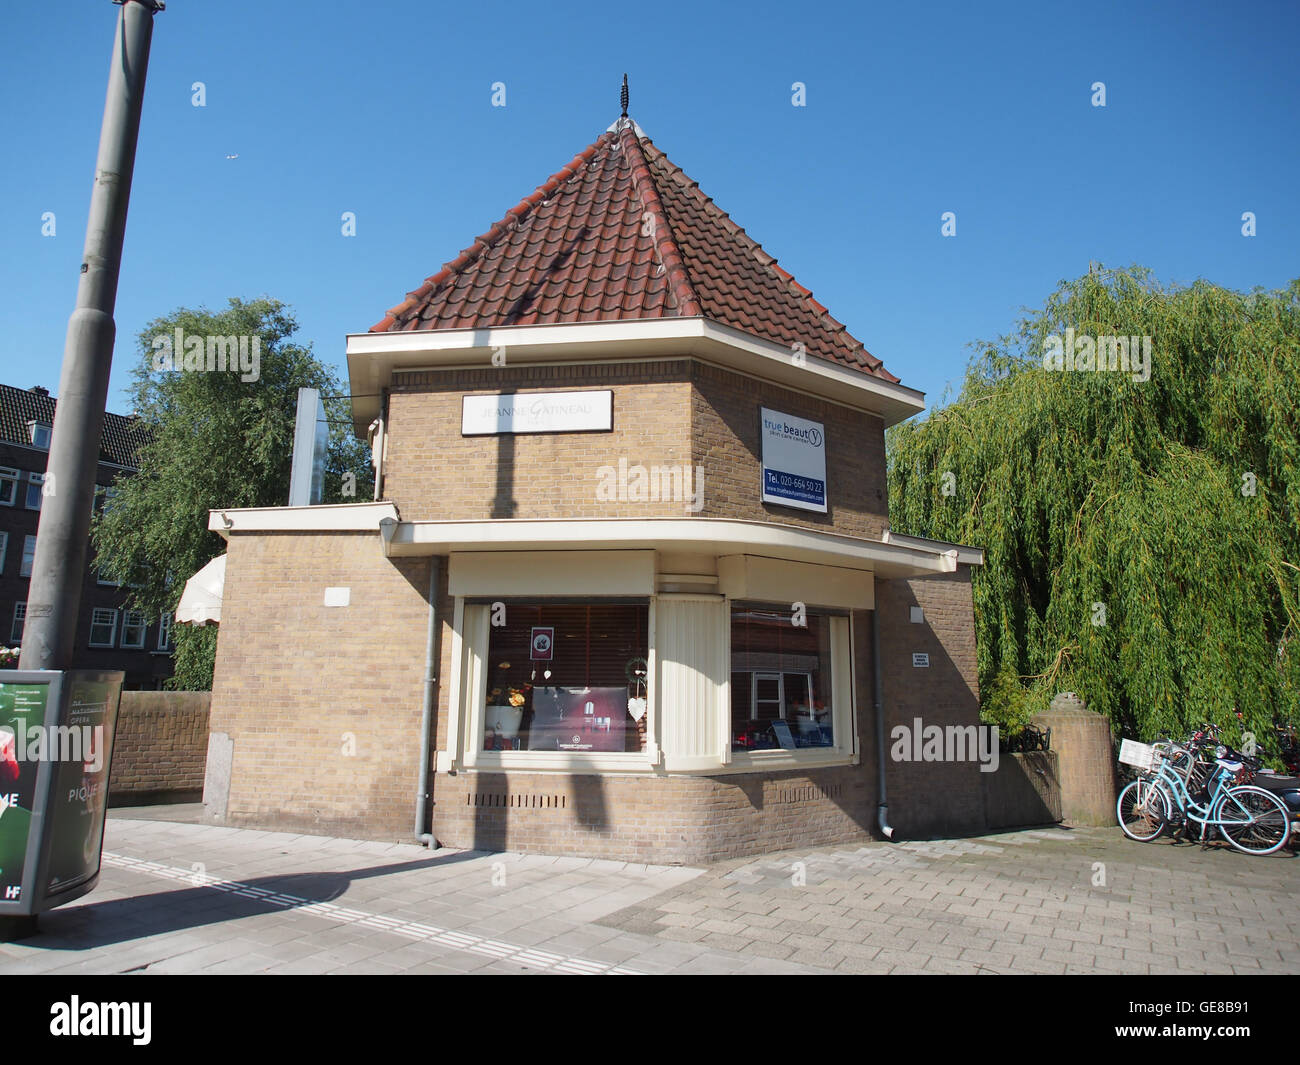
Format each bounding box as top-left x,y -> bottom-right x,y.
1115,727 -> 1291,854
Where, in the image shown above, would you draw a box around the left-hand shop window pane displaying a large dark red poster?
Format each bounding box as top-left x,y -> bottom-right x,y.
481,601 -> 649,753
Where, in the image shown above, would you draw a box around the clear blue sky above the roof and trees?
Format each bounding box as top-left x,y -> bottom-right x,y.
0,0 -> 1300,412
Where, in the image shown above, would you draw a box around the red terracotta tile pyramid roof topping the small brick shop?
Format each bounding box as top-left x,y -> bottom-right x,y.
371,124 -> 898,381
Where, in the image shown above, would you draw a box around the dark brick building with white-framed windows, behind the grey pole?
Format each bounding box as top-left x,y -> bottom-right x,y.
0,385 -> 172,689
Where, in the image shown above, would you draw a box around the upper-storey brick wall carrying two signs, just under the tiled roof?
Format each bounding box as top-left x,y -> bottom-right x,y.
384,359 -> 887,538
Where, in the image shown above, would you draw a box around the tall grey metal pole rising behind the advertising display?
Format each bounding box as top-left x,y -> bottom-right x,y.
18,0 -> 164,670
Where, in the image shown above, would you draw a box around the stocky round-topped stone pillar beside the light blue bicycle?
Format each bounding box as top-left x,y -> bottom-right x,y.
1034,692 -> 1119,824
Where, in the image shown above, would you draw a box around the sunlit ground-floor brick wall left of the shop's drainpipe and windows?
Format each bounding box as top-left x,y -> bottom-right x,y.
205,532 -> 436,839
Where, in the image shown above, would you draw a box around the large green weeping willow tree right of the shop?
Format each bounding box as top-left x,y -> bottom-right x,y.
888,268 -> 1300,749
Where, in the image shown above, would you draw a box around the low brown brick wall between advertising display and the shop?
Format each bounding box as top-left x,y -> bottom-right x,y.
108,692 -> 212,806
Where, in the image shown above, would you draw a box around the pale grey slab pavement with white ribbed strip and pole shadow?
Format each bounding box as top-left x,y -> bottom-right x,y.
0,810 -> 811,974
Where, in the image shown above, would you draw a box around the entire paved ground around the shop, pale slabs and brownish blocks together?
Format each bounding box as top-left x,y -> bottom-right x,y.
0,808 -> 1300,974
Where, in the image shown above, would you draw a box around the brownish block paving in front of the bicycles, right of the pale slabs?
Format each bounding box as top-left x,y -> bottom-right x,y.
601,828 -> 1300,974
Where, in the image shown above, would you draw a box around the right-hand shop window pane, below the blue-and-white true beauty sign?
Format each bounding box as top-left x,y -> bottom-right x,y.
731,605 -> 835,750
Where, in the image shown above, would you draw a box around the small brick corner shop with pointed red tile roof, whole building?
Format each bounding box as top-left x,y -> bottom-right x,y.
205,117 -> 984,861
